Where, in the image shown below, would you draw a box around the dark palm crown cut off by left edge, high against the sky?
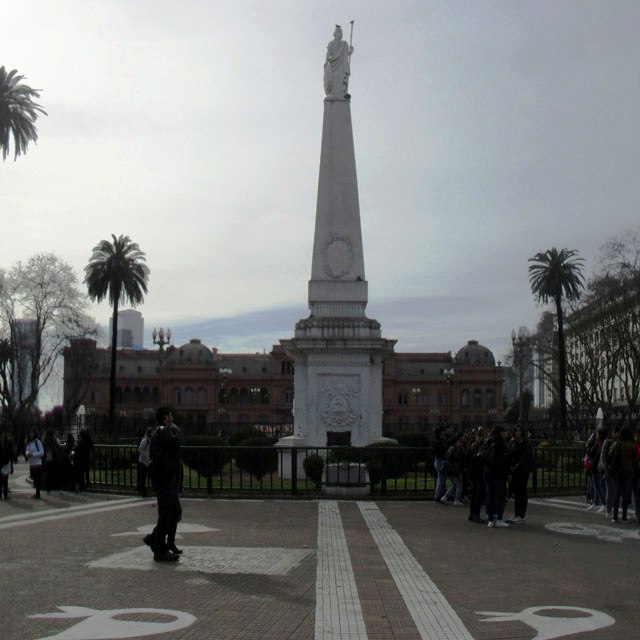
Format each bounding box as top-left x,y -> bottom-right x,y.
0,67 -> 47,160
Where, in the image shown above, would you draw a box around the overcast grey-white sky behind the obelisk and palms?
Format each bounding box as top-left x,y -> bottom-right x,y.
0,0 -> 640,358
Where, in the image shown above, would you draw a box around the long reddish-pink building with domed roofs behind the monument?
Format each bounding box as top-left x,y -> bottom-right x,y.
64,338 -> 504,434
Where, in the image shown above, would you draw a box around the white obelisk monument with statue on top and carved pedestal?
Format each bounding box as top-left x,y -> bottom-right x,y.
280,27 -> 396,447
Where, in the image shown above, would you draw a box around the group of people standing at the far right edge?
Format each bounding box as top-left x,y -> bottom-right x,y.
583,427 -> 640,522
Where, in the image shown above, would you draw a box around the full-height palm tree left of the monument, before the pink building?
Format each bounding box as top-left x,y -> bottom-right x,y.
84,234 -> 149,430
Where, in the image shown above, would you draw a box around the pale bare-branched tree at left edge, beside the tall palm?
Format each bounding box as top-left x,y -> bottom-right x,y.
0,253 -> 96,430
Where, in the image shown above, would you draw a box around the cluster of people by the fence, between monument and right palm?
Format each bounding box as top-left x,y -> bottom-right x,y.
434,425 -> 534,528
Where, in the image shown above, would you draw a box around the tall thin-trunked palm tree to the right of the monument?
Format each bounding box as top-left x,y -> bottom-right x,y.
529,247 -> 585,430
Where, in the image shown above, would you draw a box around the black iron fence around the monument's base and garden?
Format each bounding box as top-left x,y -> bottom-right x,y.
90,444 -> 585,499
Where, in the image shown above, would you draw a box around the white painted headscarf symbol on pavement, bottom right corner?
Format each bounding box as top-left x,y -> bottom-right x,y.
476,607 -> 616,640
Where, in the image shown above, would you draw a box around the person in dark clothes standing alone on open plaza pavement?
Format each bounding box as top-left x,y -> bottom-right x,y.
144,407 -> 182,561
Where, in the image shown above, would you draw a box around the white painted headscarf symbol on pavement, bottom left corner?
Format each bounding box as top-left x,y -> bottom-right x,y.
29,607 -> 196,640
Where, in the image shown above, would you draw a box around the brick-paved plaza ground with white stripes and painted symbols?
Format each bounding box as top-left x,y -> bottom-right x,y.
0,465 -> 640,640
